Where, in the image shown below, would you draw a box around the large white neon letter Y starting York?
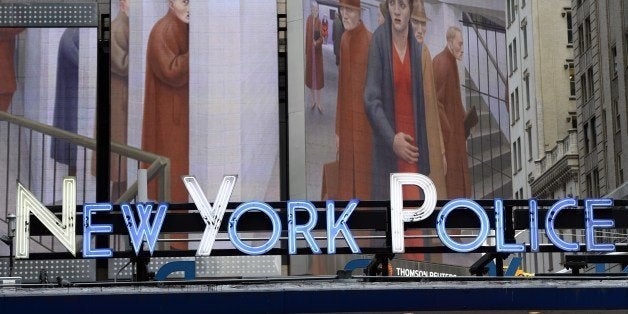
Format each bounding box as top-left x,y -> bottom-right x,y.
183,176 -> 238,256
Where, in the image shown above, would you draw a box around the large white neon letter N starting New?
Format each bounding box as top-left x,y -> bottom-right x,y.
15,177 -> 76,258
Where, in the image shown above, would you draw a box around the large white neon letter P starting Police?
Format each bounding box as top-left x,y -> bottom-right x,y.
390,173 -> 437,253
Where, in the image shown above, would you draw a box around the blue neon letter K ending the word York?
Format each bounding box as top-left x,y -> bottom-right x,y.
327,199 -> 361,254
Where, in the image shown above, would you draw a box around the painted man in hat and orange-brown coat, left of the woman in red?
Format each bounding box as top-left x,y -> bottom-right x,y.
336,0 -> 373,200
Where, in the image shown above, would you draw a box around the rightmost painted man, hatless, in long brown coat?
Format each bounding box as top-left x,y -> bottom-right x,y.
433,27 -> 471,199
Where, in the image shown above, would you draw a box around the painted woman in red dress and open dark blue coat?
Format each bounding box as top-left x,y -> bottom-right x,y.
364,0 -> 430,199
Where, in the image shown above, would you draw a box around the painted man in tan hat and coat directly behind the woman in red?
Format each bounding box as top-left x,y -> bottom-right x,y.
410,0 -> 447,198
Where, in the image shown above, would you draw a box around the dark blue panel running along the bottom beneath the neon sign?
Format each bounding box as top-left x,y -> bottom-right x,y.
0,282 -> 628,314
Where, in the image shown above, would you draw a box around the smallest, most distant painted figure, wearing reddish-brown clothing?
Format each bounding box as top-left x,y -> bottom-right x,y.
305,0 -> 325,113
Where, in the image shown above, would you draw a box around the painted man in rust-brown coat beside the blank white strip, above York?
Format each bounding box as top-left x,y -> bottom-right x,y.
142,0 -> 189,203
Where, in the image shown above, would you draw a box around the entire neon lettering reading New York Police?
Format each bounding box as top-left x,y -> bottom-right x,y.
15,173 -> 615,258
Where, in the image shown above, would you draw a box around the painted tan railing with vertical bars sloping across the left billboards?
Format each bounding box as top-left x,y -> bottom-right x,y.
0,111 -> 170,252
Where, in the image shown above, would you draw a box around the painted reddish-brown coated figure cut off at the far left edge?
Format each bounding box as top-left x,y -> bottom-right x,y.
0,28 -> 24,111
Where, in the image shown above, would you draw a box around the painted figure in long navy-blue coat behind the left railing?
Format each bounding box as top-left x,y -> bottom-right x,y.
50,28 -> 79,175
